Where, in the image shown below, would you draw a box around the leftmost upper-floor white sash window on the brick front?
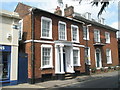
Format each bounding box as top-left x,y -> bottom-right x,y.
41,17 -> 52,39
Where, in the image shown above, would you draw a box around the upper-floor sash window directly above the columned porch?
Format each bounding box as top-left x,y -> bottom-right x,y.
58,21 -> 67,40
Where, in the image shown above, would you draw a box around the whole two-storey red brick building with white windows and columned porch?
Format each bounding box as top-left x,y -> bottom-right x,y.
15,3 -> 118,83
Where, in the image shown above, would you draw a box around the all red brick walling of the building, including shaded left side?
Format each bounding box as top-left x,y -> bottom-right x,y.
15,5 -> 118,78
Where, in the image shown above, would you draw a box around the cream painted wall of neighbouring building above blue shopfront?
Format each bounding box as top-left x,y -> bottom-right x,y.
0,10 -> 20,80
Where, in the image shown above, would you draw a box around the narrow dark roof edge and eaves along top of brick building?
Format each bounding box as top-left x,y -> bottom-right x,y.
15,3 -> 119,31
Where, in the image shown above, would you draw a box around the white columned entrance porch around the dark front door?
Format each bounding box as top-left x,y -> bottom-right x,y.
55,45 -> 74,74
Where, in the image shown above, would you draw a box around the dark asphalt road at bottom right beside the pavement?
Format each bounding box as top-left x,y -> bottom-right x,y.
64,73 -> 120,89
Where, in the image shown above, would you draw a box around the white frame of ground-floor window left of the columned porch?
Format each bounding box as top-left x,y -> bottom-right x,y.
41,44 -> 53,69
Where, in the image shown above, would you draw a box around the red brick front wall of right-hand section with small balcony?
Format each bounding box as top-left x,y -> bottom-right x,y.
88,26 -> 118,67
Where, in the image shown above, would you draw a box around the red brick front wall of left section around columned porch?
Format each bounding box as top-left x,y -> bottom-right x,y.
32,12 -> 85,78
